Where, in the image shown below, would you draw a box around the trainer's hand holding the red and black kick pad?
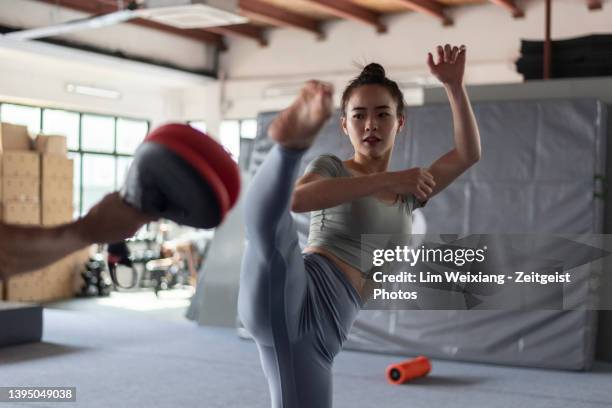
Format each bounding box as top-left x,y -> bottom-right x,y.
77,192 -> 156,243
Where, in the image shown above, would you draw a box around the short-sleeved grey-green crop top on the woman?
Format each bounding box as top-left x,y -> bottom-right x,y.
305,154 -> 421,276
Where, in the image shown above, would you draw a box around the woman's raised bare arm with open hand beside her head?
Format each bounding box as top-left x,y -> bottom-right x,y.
427,44 -> 481,195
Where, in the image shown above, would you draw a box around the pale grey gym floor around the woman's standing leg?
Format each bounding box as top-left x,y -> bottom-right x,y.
0,300 -> 612,408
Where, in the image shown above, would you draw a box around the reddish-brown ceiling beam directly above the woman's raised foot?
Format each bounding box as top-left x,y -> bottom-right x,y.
239,0 -> 323,39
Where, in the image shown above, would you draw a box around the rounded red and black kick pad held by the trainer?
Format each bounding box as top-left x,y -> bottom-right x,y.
121,123 -> 240,228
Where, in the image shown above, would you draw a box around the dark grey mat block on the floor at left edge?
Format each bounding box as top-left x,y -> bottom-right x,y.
0,302 -> 43,347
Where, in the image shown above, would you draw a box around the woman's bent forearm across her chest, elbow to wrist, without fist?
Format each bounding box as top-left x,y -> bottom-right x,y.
291,172 -> 391,212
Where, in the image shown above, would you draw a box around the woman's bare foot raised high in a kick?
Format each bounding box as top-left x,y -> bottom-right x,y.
268,81 -> 333,149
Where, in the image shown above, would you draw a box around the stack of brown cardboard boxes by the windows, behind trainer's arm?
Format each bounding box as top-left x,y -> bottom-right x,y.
0,123 -> 89,301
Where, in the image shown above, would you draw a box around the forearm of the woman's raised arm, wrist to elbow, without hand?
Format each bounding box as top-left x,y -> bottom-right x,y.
445,83 -> 481,165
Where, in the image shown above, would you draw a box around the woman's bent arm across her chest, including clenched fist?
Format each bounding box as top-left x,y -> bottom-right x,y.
291,168 -> 436,212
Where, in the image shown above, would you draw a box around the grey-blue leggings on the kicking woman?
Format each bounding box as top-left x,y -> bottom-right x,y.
238,146 -> 361,408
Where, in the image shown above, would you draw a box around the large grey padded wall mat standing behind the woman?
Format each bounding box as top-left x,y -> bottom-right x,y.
249,99 -> 606,369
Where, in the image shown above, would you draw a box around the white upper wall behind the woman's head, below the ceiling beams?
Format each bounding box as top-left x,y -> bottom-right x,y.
201,0 -> 612,130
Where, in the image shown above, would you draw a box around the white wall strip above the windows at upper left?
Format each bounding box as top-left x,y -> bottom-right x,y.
0,39 -> 218,125
